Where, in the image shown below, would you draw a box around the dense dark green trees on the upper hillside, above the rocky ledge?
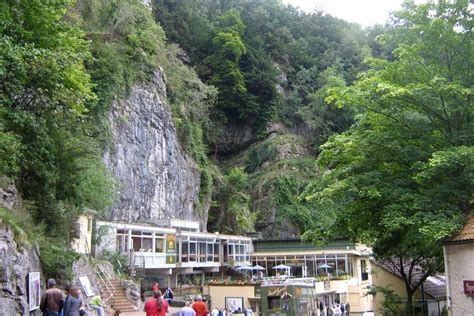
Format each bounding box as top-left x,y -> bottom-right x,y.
155,0 -> 365,148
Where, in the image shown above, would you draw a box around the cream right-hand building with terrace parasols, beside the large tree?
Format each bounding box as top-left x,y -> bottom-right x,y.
251,238 -> 373,315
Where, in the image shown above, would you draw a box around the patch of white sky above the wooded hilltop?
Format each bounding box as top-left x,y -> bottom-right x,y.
283,0 -> 421,26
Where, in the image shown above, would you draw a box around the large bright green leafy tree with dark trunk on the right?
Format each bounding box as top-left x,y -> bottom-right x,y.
305,1 -> 474,315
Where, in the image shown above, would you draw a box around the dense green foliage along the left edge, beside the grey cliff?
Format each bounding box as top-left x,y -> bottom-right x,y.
0,1 -> 113,242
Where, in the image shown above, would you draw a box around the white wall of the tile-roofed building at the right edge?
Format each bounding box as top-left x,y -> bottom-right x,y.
445,242 -> 474,316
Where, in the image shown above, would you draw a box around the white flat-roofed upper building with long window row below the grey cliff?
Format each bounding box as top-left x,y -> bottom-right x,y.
95,220 -> 252,287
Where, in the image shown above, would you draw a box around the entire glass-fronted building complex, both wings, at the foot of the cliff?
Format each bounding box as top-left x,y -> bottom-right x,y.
94,220 -> 372,315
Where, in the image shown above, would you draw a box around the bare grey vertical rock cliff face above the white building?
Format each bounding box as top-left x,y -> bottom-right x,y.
104,70 -> 207,227
